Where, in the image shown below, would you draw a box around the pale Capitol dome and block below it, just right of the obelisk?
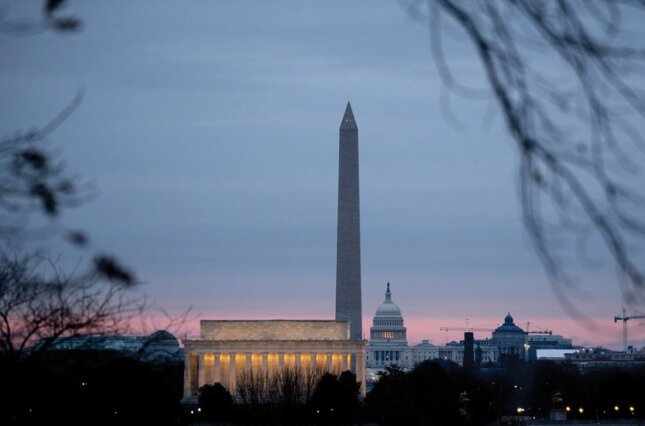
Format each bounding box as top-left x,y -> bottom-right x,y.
366,283 -> 411,368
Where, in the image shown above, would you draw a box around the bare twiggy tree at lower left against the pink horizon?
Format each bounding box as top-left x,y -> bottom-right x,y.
0,253 -> 140,362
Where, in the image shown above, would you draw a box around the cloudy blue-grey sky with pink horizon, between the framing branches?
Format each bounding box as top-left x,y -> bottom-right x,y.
0,0 -> 645,347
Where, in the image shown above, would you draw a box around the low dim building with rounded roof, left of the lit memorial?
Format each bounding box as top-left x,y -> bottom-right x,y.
36,330 -> 183,362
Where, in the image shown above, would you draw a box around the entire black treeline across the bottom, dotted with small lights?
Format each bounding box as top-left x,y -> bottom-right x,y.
5,351 -> 645,425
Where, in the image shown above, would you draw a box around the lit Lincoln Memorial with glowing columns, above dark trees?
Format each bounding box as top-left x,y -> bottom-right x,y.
184,320 -> 367,402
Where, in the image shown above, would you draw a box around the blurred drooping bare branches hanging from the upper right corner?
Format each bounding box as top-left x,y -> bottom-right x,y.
400,0 -> 645,317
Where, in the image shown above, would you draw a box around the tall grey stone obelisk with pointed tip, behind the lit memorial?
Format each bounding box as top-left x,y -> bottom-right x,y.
336,102 -> 363,340
